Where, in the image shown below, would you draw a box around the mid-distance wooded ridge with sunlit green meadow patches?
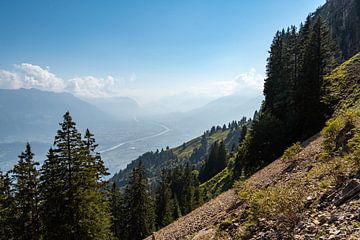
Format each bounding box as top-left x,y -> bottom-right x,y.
110,117 -> 252,187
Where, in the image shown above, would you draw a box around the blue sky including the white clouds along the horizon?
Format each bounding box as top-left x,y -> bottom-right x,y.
0,0 -> 325,101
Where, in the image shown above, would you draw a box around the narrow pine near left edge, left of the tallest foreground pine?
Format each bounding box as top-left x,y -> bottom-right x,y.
12,143 -> 40,240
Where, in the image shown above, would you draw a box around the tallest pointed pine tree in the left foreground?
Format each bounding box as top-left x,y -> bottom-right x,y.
42,112 -> 83,239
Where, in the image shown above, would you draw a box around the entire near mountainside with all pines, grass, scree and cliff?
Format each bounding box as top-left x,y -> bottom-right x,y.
0,0 -> 360,240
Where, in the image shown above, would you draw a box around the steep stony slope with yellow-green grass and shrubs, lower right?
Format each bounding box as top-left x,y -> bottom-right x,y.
149,54 -> 360,240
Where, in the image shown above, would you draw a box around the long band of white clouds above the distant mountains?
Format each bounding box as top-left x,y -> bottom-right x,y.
0,63 -> 264,102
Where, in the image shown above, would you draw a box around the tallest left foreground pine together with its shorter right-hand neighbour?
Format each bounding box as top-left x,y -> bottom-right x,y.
41,112 -> 112,239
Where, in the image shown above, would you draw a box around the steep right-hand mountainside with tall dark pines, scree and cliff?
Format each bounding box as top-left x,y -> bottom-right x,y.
148,1 -> 360,239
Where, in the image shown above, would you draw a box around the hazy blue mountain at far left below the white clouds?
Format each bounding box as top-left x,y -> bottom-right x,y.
0,89 -> 111,142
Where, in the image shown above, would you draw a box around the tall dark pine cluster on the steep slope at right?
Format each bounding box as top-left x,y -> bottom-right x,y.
234,15 -> 338,177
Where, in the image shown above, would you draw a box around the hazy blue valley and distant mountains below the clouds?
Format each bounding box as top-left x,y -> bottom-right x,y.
0,89 -> 262,172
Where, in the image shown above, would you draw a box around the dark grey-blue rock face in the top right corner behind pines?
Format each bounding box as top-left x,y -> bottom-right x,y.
315,0 -> 360,60
